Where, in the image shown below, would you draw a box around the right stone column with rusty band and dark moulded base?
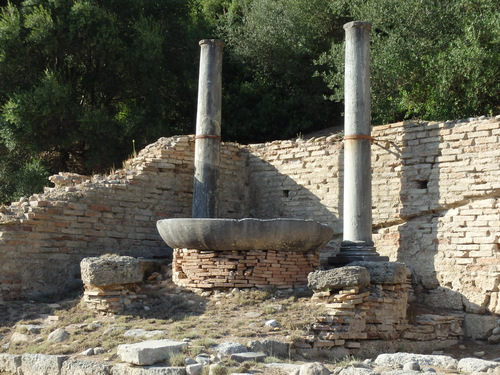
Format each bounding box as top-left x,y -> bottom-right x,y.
334,21 -> 388,264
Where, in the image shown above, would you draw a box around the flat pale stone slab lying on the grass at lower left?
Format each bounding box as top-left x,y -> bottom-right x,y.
117,339 -> 187,366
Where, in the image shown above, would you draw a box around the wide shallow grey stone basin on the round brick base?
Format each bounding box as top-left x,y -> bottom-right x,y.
156,218 -> 333,251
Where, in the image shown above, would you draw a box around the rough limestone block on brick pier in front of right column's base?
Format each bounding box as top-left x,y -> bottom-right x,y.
307,266 -> 370,292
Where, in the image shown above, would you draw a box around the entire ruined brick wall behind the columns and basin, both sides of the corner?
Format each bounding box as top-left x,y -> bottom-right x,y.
0,116 -> 500,314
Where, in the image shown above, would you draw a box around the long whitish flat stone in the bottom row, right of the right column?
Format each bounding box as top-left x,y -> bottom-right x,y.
375,353 -> 458,370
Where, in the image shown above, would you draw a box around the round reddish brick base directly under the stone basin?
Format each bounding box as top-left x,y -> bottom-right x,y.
172,249 -> 319,289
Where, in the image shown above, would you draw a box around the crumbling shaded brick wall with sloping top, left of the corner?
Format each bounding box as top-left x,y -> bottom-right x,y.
0,136 -> 250,302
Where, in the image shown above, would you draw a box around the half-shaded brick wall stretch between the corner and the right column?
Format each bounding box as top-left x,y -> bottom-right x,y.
243,142 -> 342,258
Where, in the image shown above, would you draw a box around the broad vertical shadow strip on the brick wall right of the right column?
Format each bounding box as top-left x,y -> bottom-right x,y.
397,122 -> 485,313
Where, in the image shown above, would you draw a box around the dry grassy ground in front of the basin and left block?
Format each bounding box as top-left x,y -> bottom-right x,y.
0,288 -> 319,366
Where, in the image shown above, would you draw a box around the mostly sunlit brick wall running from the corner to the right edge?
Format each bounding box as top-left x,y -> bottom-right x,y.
248,116 -> 500,314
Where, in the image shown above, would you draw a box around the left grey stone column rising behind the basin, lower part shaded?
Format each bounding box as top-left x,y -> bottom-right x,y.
192,39 -> 224,218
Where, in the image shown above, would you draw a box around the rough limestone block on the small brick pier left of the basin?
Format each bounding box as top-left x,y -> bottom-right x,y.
80,256 -> 143,286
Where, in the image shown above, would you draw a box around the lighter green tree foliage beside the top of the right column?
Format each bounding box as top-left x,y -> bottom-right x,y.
319,0 -> 500,123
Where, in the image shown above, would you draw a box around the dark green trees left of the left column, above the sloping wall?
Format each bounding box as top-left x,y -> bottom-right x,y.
0,0 -> 201,202
